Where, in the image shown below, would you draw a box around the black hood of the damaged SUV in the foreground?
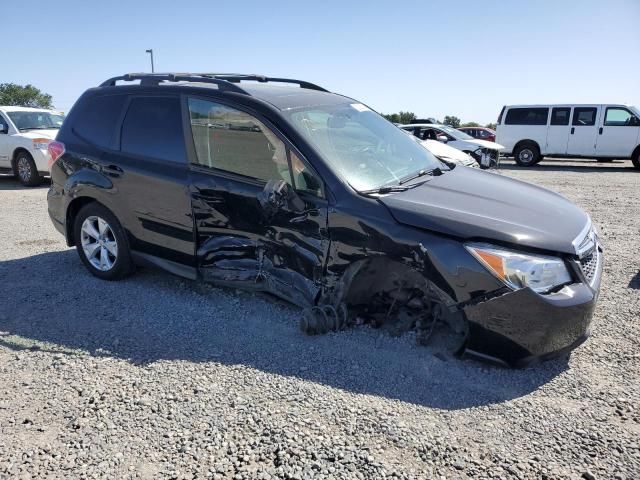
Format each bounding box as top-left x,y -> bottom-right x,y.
379,168 -> 590,254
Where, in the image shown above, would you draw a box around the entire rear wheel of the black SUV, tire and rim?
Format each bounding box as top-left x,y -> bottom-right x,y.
73,202 -> 134,280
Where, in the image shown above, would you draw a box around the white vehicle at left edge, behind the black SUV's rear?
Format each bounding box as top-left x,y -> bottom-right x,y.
0,106 -> 64,187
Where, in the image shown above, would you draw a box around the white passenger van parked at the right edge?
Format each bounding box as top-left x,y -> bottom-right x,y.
496,104 -> 640,169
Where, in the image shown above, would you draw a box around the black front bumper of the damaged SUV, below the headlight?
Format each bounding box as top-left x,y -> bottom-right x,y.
463,248 -> 603,367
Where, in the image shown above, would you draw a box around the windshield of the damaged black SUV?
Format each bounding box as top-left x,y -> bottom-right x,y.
285,103 -> 446,191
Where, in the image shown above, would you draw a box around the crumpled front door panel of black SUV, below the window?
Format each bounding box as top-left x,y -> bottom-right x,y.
191,167 -> 329,305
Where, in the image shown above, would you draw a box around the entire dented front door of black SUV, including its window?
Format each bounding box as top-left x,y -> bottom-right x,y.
184,97 -> 329,305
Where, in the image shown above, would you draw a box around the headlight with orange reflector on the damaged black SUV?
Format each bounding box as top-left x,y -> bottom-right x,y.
465,244 -> 571,293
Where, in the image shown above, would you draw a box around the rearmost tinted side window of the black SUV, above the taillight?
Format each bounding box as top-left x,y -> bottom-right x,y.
72,95 -> 127,150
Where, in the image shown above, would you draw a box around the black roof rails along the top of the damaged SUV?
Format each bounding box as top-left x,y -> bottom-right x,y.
100,73 -> 328,95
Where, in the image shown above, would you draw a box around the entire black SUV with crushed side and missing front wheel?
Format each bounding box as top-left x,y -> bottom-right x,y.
48,74 -> 602,366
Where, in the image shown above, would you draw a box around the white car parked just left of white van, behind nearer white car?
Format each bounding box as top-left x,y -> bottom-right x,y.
400,123 -> 503,168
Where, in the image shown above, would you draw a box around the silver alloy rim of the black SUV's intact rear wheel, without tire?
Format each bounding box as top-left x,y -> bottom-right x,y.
80,216 -> 118,272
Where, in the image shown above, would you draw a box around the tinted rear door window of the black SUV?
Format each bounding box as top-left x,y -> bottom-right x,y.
120,97 -> 187,163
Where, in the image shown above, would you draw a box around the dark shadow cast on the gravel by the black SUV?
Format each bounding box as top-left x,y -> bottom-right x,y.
0,250 -> 568,410
